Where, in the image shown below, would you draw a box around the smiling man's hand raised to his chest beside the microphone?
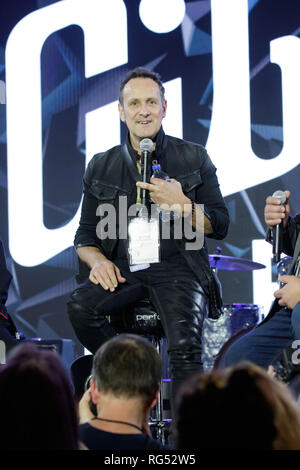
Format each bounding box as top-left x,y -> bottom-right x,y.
136,178 -> 191,215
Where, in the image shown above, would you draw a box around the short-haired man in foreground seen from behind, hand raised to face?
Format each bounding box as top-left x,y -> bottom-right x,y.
79,334 -> 163,450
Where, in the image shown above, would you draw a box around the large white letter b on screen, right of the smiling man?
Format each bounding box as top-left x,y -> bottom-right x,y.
207,0 -> 300,196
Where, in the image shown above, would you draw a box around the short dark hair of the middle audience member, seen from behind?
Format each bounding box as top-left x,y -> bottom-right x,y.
92,334 -> 161,404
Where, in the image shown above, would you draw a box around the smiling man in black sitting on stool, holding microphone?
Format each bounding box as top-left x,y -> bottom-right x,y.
68,68 -> 229,412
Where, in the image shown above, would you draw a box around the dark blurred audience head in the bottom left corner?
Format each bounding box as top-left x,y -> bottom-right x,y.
0,343 -> 78,450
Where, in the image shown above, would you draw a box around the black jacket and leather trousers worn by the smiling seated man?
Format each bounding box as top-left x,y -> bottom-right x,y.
68,129 -> 229,408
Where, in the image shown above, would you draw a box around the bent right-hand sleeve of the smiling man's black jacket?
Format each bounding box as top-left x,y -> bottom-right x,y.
195,148 -> 229,240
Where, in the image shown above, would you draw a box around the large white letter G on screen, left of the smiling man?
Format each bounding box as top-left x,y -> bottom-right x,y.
6,0 -> 128,266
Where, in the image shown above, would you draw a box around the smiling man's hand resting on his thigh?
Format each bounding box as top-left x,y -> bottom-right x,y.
89,259 -> 126,292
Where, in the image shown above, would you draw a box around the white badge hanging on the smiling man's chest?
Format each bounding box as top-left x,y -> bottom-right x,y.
128,217 -> 160,265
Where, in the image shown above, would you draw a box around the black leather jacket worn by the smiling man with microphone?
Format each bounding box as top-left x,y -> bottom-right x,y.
74,128 -> 229,318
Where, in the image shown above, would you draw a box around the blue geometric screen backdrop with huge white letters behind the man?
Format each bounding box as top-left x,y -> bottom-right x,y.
0,0 -> 300,351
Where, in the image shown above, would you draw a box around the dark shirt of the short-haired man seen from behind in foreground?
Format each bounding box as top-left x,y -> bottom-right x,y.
79,423 -> 164,451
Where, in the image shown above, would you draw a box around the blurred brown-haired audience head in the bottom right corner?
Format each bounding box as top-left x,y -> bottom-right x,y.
176,363 -> 300,450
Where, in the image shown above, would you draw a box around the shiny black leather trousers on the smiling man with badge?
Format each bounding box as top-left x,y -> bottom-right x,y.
68,256 -> 207,406
